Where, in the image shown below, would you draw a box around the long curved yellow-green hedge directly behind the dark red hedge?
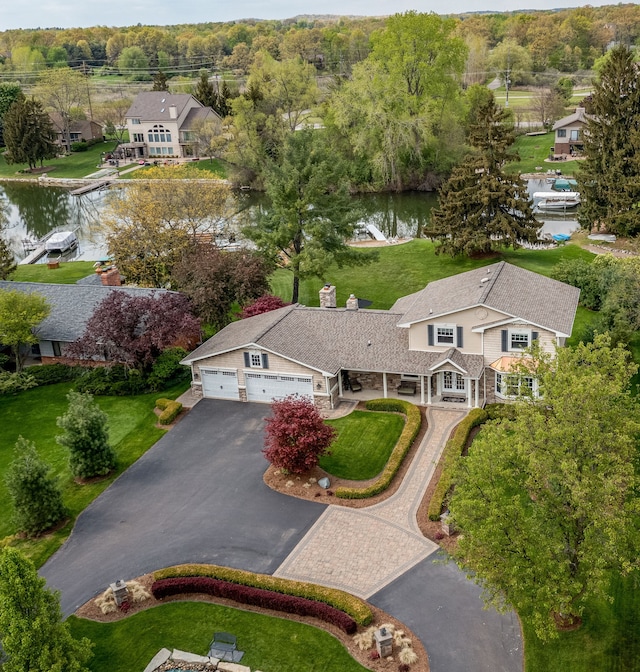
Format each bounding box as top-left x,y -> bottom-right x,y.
153,565 -> 373,625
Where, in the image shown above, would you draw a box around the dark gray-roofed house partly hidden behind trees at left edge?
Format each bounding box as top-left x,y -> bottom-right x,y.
0,279 -> 172,364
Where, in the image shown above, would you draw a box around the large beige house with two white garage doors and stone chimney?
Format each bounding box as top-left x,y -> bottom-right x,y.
182,262 -> 580,409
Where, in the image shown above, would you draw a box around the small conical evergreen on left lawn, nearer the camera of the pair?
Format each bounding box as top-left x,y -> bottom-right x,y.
5,436 -> 67,540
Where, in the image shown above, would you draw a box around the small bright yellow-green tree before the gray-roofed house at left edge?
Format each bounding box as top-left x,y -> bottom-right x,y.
0,290 -> 50,373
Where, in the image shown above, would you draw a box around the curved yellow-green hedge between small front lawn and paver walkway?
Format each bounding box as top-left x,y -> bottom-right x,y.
336,399 -> 422,499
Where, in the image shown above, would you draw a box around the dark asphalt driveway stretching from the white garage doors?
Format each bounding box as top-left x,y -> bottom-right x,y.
41,399 -> 325,614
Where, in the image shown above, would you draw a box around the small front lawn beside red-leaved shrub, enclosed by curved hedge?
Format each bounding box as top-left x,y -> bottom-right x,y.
320,411 -> 404,481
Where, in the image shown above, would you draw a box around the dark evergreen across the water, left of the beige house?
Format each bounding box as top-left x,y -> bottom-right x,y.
3,98 -> 58,170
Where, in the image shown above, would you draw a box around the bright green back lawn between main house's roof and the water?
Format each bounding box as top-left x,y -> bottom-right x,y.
271,239 -> 594,309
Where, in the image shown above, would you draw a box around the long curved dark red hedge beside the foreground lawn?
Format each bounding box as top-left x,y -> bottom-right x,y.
151,576 -> 358,635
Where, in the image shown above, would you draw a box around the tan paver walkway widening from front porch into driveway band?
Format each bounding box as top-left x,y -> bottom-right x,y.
275,408 -> 465,599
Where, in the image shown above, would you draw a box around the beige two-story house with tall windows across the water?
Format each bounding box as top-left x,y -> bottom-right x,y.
120,91 -> 220,159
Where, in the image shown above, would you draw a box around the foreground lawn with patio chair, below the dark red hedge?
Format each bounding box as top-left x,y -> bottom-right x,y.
68,602 -> 366,672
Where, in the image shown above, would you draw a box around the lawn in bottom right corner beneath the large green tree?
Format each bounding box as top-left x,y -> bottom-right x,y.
522,575 -> 640,672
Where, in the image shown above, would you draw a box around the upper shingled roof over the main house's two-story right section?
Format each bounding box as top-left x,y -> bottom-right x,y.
391,261 -> 580,337
